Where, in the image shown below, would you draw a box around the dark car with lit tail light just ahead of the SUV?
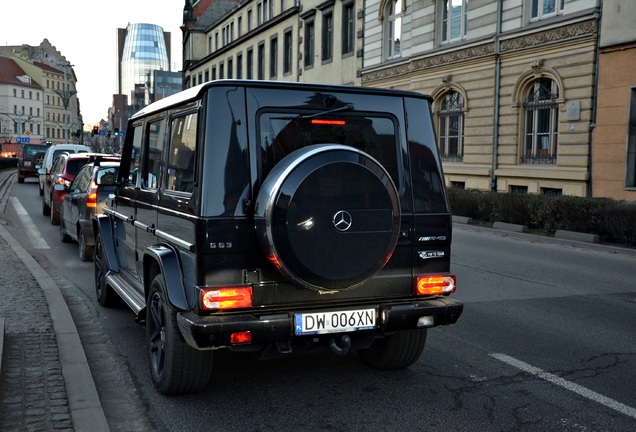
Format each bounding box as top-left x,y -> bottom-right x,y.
60,156 -> 119,261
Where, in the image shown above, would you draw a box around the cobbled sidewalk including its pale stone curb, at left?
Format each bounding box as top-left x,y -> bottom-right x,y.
0,170 -> 109,432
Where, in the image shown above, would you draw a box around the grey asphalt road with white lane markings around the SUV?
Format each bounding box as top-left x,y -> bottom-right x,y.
7,176 -> 636,432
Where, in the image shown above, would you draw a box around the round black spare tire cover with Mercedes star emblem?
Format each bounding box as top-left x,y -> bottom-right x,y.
255,144 -> 400,291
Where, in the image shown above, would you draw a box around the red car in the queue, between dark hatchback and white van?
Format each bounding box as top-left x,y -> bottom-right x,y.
42,152 -> 120,225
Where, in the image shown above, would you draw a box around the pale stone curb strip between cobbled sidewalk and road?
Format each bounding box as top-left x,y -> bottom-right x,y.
0,213 -> 110,432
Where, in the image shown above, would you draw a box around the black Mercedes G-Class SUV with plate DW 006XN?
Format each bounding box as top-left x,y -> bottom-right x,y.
95,80 -> 463,394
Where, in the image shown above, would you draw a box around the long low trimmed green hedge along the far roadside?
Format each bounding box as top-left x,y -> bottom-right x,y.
448,189 -> 636,246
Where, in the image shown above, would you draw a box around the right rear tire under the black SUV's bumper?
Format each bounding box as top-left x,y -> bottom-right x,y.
358,329 -> 426,370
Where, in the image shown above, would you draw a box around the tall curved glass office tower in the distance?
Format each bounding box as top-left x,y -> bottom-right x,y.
119,24 -> 170,110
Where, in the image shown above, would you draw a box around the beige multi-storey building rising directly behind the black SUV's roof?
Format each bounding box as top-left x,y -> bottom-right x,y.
183,0 -> 363,87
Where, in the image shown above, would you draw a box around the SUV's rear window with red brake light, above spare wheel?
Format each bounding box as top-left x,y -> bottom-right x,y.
259,112 -> 400,185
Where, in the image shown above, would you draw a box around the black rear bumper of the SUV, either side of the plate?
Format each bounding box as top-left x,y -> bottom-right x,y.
177,297 -> 464,349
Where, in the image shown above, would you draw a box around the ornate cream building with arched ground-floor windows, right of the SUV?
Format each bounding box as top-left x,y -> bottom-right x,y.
361,0 -> 600,196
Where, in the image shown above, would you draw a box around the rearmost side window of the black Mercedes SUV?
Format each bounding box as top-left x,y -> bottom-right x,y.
166,113 -> 197,192
